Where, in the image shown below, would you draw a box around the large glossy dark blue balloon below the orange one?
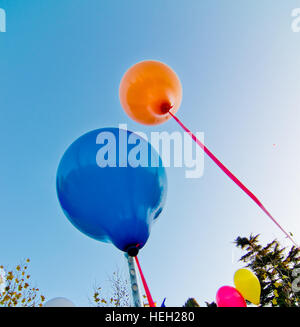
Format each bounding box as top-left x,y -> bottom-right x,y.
56,128 -> 167,255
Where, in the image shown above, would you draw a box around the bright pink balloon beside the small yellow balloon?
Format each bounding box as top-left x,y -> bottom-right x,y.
216,286 -> 247,307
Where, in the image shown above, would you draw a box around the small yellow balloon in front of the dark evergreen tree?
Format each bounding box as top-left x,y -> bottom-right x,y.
234,268 -> 261,305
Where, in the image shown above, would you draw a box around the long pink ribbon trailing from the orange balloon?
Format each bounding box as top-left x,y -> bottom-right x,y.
169,111 -> 298,248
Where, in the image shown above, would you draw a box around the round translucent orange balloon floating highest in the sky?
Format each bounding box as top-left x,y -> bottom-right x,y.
119,60 -> 182,125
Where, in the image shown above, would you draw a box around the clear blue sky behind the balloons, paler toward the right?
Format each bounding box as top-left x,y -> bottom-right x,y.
0,0 -> 300,306
